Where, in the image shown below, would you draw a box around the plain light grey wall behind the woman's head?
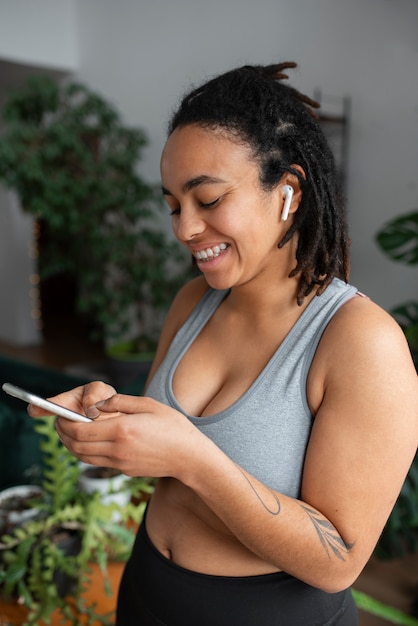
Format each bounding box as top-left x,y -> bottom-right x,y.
74,0 -> 418,307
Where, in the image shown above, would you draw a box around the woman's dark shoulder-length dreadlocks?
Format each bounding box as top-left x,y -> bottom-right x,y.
168,62 -> 350,304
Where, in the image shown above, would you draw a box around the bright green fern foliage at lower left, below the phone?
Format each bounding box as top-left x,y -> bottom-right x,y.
0,417 -> 153,626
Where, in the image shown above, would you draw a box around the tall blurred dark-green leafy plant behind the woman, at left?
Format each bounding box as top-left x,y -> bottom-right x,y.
0,74 -> 192,386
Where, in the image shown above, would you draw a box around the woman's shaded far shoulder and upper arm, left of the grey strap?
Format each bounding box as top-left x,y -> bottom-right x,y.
149,276 -> 209,380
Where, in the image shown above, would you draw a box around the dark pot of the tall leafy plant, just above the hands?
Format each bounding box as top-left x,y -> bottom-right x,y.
106,341 -> 155,390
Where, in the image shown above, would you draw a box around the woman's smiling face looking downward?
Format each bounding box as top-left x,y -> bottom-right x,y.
161,125 -> 294,289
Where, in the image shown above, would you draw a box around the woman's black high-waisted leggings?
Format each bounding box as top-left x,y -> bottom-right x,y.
116,523 -> 358,626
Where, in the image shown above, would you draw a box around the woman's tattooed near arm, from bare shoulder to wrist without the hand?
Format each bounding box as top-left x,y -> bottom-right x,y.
177,298 -> 418,592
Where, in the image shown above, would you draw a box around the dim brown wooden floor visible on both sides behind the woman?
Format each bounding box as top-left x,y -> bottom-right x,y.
0,320 -> 418,626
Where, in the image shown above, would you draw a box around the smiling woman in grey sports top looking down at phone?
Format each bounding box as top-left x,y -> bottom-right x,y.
30,63 -> 418,626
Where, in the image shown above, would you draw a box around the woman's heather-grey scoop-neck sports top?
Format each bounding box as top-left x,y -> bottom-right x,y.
147,279 -> 357,498
